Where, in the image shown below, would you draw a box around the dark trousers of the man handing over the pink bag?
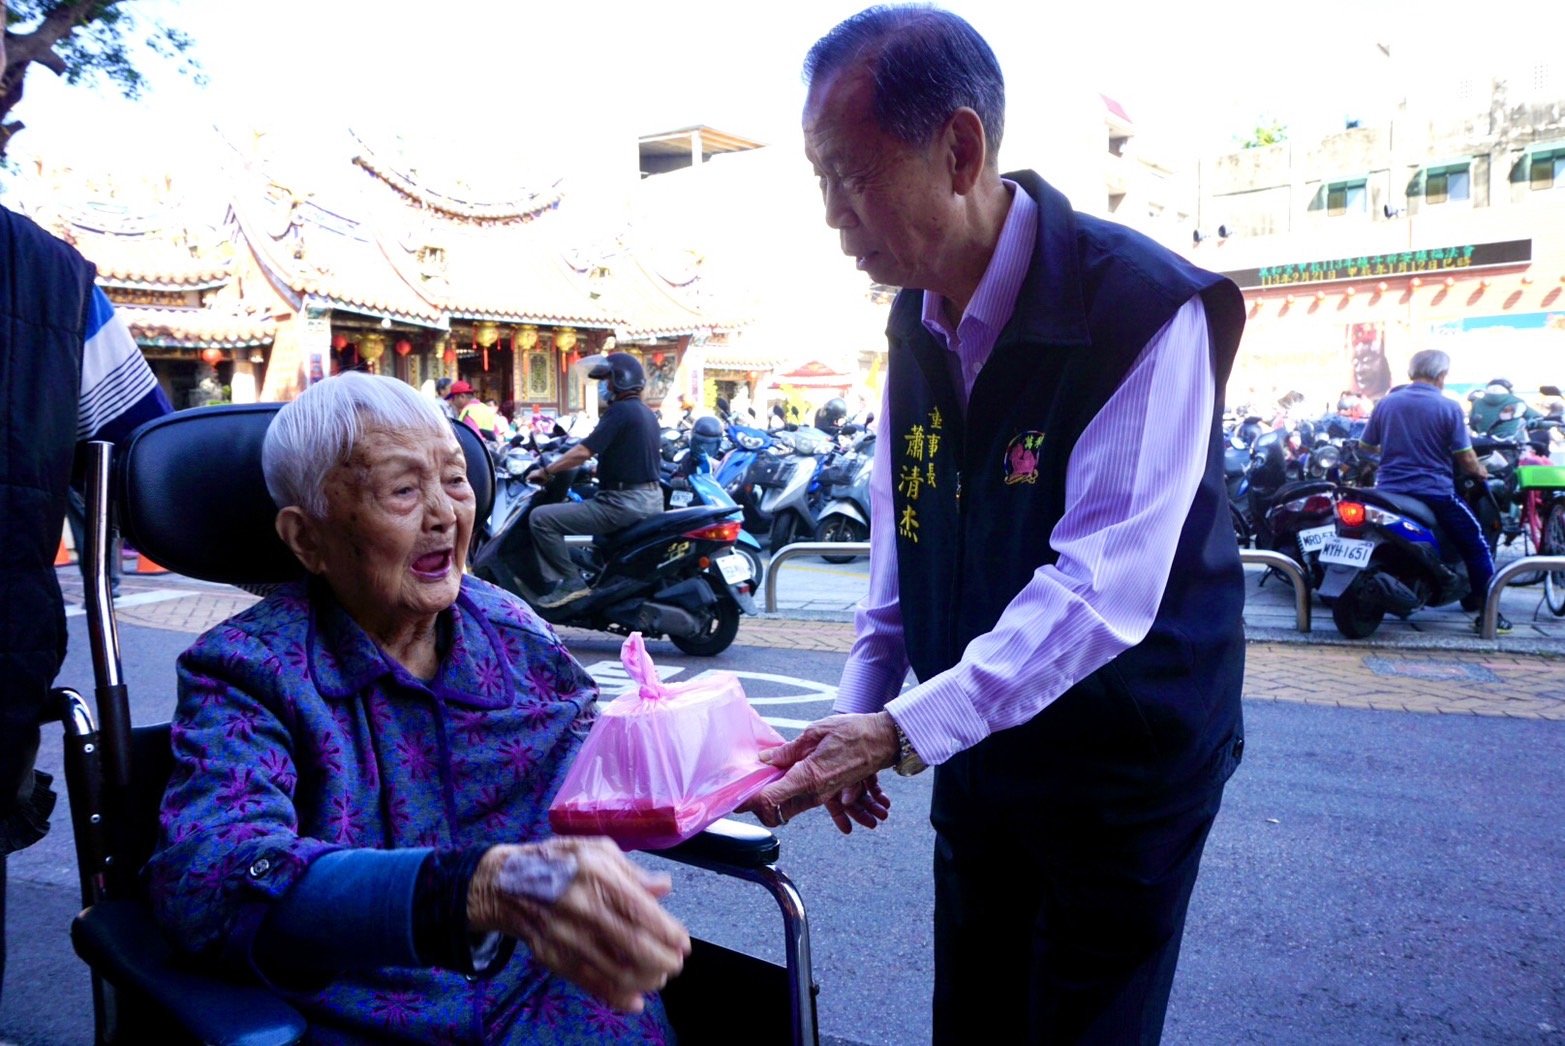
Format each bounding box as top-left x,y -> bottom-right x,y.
930,707 -> 1239,1044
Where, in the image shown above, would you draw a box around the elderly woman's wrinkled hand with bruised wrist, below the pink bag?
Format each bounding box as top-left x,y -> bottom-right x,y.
468,838 -> 690,1013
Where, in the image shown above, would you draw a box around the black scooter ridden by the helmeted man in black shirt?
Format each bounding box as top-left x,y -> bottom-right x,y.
473,457 -> 756,656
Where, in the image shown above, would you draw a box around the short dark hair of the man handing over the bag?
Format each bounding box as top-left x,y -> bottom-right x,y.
804,3 -> 1005,164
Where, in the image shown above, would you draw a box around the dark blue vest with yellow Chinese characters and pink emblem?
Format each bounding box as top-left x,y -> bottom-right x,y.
886,172 -> 1244,792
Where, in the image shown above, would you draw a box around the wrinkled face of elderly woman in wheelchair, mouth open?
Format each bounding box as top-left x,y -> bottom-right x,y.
309,429 -> 476,634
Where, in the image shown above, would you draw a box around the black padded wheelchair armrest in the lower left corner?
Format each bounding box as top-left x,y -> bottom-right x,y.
70,900 -> 308,1046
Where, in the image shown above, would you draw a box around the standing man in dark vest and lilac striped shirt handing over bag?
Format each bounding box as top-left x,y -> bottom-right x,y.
748,6 -> 1244,1043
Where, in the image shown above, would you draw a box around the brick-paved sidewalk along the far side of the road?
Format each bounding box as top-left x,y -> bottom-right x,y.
59,567 -> 1565,720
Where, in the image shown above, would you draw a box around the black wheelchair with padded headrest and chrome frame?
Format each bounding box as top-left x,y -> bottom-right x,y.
55,404 -> 818,1046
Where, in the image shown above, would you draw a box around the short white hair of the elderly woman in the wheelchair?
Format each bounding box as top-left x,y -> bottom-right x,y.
261,371 -> 451,520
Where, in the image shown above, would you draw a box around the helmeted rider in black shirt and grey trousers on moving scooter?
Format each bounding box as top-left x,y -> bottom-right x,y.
527,352 -> 664,609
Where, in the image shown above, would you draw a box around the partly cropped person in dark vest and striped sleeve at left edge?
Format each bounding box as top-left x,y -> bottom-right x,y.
0,203 -> 169,995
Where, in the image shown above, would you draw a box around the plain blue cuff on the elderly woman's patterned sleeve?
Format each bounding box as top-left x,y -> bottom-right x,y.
255,849 -> 430,972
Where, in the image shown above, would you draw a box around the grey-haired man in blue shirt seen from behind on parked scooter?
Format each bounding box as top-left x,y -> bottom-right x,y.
1358,349 -> 1510,633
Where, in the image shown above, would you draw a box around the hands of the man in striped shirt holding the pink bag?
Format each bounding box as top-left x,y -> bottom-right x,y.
743,712 -> 897,833
